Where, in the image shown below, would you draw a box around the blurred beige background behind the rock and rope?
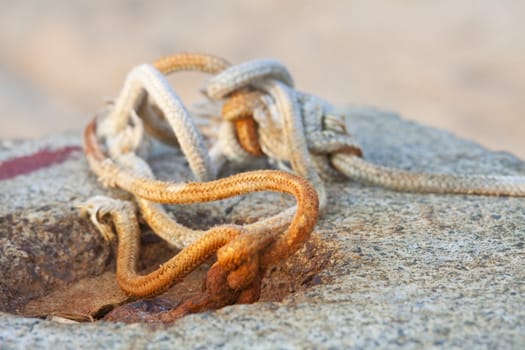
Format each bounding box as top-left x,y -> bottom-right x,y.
0,0 -> 525,159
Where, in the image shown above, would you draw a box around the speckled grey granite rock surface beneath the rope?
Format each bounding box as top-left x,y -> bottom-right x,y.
0,109 -> 525,349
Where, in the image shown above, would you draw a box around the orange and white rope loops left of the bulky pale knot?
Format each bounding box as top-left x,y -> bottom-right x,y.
84,55 -> 318,320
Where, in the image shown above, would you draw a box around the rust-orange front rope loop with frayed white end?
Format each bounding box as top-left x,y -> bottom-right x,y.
84,119 -> 318,314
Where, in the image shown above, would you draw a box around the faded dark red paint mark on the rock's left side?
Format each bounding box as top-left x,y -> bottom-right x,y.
0,146 -> 82,180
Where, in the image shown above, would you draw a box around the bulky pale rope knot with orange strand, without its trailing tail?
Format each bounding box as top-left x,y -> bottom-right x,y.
205,60 -> 362,183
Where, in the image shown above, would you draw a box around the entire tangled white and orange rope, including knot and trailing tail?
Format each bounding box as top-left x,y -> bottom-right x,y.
85,54 -> 525,322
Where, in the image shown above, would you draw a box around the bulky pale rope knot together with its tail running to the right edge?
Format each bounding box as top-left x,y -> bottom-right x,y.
138,54 -> 525,197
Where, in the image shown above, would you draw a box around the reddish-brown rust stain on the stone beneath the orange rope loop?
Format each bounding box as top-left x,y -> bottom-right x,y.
83,234 -> 338,323
